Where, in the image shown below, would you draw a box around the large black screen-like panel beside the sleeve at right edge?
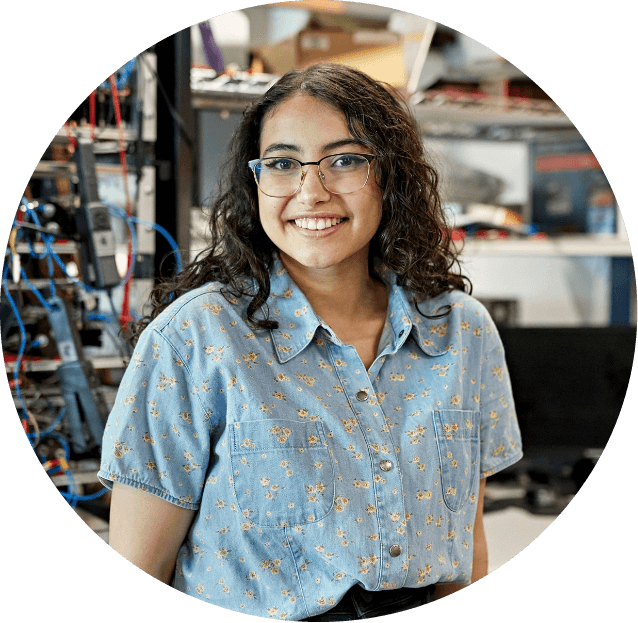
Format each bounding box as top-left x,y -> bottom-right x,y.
499,326 -> 636,452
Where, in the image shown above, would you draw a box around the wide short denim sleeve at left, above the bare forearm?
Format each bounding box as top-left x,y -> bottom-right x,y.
98,327 -> 211,510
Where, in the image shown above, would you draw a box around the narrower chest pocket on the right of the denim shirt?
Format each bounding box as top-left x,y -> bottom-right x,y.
433,409 -> 480,512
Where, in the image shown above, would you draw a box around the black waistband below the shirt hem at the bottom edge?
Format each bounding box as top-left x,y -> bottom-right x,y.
302,585 -> 434,623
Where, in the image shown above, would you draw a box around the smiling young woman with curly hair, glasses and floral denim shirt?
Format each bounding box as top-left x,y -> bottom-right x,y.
99,65 -> 522,621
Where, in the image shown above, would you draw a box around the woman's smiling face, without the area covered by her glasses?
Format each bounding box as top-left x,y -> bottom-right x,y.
258,95 -> 381,269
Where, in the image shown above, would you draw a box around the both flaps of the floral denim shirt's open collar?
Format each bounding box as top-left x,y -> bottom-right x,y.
268,256 -> 458,363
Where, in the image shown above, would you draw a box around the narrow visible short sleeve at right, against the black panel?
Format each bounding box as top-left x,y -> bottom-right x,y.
480,312 -> 523,478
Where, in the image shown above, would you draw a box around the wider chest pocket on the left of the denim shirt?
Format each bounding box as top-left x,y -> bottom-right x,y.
230,420 -> 335,527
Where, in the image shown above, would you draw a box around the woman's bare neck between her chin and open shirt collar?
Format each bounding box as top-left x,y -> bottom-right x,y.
280,253 -> 387,324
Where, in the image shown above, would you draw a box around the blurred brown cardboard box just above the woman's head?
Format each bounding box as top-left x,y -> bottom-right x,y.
253,28 -> 407,87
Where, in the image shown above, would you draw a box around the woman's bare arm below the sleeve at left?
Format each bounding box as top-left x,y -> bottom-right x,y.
109,482 -> 196,584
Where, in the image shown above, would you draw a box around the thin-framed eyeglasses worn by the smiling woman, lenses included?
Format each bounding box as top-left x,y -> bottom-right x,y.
248,154 -> 375,197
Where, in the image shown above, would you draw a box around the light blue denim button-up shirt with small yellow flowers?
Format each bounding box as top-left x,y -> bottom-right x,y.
99,260 -> 522,621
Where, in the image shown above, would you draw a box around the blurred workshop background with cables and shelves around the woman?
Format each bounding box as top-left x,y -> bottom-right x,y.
0,0 -> 637,571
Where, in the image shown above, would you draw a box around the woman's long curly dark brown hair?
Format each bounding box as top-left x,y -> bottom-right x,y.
129,63 -> 472,341
